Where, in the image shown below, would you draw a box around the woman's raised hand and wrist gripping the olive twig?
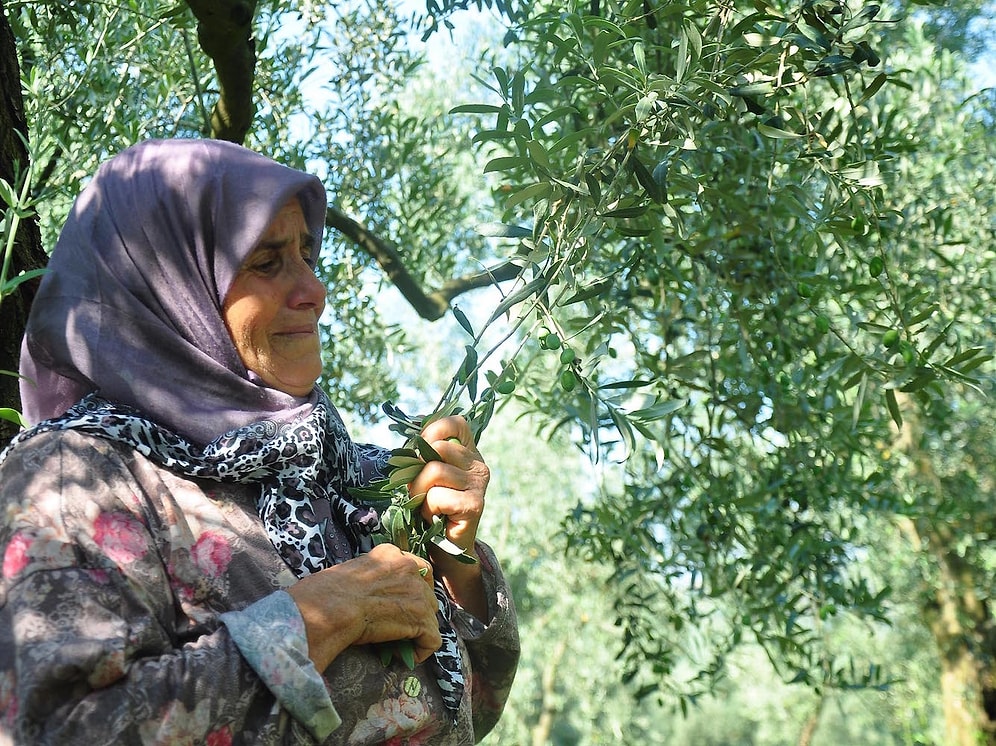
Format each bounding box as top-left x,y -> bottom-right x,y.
408,417 -> 491,622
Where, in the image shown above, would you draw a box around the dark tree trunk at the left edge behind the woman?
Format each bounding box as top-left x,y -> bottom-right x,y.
0,0 -> 47,448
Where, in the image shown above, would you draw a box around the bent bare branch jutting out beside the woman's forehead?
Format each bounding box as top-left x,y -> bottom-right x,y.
325,206 -> 519,321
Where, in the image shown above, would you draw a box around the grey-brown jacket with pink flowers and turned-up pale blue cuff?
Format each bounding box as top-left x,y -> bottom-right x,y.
0,430 -> 519,746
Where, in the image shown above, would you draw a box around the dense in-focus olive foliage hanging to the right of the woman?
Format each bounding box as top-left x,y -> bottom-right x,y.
444,2 -> 993,709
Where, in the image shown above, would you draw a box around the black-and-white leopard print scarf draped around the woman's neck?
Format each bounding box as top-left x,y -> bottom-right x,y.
0,393 -> 465,718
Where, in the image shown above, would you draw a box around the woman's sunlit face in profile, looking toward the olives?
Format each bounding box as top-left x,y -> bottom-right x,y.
222,198 -> 325,396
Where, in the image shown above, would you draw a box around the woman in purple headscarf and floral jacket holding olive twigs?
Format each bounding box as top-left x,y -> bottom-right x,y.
0,140 -> 518,745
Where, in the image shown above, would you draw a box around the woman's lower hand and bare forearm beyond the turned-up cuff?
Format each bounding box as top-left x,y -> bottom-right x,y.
287,544 -> 442,671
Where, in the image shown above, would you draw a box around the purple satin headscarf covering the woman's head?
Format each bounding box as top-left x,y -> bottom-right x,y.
20,140 -> 326,444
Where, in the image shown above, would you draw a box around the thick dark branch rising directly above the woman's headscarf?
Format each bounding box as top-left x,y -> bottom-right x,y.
187,0 -> 256,144
